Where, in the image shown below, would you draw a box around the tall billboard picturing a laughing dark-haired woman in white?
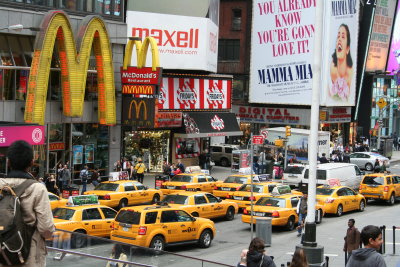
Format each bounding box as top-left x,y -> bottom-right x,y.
321,0 -> 359,106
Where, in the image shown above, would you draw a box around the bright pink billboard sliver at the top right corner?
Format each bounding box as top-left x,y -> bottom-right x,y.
386,0 -> 400,74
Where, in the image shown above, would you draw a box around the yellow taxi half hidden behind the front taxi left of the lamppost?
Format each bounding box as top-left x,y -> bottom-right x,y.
227,182 -> 302,209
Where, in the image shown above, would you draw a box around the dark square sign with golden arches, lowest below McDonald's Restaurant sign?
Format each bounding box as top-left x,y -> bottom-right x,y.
122,95 -> 158,128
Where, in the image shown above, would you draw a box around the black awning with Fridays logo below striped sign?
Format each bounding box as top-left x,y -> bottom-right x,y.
175,112 -> 243,138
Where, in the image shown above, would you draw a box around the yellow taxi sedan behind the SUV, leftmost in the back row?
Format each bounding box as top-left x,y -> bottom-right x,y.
84,180 -> 163,209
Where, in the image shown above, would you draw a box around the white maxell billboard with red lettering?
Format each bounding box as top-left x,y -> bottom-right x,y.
126,11 -> 218,72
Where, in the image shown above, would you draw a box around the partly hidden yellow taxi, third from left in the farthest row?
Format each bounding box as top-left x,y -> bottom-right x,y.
213,174 -> 259,198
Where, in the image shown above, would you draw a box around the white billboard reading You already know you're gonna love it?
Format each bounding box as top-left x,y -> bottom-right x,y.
249,0 -> 316,105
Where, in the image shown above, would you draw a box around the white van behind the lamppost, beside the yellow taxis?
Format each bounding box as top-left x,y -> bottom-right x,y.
301,163 -> 364,190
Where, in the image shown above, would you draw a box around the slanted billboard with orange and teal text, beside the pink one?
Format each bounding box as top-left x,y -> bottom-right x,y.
365,0 -> 397,72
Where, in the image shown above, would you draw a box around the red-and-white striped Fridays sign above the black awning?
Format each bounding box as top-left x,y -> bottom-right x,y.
158,77 -> 232,110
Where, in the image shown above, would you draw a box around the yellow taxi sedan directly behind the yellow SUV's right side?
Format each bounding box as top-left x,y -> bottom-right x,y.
162,191 -> 239,221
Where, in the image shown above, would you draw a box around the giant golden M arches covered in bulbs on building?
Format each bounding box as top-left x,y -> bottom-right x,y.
25,11 -> 116,125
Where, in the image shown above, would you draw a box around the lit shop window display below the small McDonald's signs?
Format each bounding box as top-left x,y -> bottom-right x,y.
124,131 -> 170,171
